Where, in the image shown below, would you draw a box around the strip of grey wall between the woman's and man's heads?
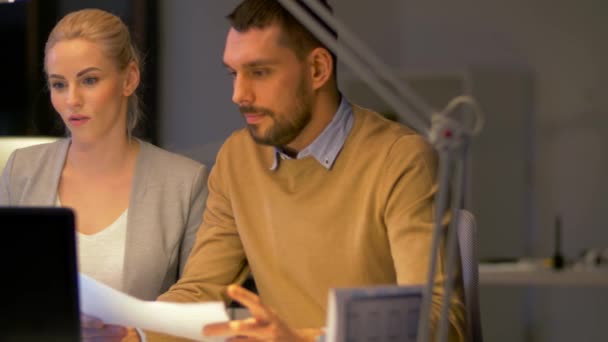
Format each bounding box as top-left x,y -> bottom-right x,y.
160,0 -> 242,164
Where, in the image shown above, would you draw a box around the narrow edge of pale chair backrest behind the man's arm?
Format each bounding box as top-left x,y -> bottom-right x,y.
457,209 -> 483,342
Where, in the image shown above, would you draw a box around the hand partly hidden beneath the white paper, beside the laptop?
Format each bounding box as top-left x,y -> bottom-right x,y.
80,314 -> 139,342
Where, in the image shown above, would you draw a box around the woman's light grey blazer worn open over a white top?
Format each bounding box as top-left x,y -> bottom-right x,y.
0,139 -> 208,300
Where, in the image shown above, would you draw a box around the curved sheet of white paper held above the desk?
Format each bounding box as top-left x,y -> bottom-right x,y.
78,273 -> 228,341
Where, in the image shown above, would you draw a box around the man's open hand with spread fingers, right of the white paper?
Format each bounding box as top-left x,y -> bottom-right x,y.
203,285 -> 322,342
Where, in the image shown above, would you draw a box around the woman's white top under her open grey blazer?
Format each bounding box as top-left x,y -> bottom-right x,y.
77,208 -> 129,291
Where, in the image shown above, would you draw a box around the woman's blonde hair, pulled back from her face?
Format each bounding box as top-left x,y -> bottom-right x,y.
44,9 -> 143,137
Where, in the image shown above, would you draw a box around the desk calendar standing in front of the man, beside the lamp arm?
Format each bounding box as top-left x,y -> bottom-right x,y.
326,285 -> 422,342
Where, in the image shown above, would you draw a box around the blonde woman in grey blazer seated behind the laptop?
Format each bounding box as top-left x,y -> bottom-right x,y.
0,9 -> 207,300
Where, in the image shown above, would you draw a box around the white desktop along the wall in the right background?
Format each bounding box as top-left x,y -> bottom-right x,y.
479,263 -> 608,287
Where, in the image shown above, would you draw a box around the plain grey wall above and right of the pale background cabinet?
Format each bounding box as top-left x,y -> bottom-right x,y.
334,0 -> 608,255
